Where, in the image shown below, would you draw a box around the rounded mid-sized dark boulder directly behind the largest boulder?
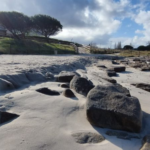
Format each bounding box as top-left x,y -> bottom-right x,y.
70,76 -> 94,96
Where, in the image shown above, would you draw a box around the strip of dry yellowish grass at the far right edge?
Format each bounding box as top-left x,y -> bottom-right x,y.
120,50 -> 150,57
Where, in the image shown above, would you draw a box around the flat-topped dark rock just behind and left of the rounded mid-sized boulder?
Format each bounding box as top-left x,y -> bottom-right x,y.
56,71 -> 79,82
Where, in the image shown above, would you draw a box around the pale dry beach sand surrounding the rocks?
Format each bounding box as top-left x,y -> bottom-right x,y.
0,55 -> 150,150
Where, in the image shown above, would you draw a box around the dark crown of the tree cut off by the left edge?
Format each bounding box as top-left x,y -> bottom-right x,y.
0,11 -> 32,39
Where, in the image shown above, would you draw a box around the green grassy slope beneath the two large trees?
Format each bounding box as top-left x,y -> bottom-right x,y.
0,38 -> 75,54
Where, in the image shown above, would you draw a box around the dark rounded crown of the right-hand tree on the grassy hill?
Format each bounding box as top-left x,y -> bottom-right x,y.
31,14 -> 62,39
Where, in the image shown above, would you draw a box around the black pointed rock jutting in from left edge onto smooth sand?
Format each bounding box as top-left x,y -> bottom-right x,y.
0,111 -> 19,124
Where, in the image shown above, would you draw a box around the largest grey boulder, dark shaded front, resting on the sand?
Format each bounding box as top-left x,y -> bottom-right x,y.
86,86 -> 142,132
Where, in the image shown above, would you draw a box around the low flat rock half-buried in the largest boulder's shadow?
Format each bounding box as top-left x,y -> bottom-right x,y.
106,130 -> 141,140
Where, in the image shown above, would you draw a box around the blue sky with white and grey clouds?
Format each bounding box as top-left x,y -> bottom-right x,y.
0,0 -> 150,47
